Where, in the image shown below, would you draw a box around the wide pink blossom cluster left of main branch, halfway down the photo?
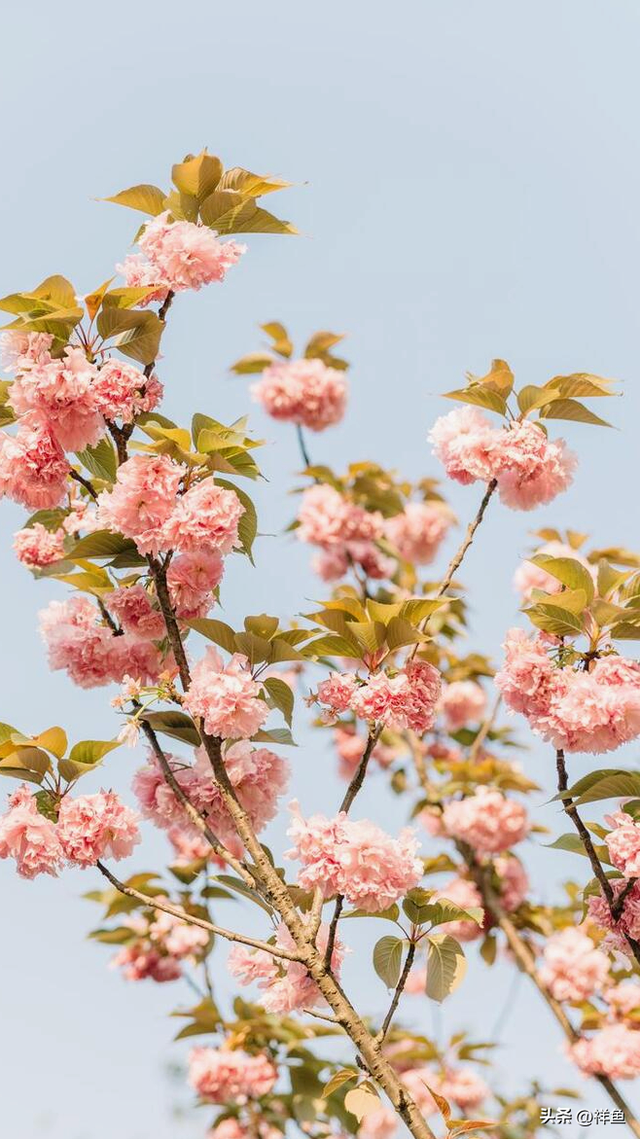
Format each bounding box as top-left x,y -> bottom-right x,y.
40,595 -> 165,688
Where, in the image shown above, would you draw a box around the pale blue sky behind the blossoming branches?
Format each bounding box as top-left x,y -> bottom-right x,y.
0,0 -> 640,1139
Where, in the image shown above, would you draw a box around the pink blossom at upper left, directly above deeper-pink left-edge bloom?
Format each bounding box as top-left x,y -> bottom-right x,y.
10,347 -> 105,451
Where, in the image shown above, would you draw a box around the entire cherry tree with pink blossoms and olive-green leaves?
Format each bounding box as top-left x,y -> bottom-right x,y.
0,150 -> 640,1139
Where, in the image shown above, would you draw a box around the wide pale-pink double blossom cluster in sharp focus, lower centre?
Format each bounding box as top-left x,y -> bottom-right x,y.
285,803 -> 422,913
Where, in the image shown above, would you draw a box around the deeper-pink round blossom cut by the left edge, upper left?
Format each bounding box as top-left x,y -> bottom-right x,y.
0,415 -> 69,510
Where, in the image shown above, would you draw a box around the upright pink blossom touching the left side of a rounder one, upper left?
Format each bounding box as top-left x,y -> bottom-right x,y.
97,454 -> 183,555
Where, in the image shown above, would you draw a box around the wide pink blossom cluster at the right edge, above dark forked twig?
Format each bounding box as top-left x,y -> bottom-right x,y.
495,629 -> 640,754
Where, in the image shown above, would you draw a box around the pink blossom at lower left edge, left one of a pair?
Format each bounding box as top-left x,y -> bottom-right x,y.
0,784 -> 64,878
